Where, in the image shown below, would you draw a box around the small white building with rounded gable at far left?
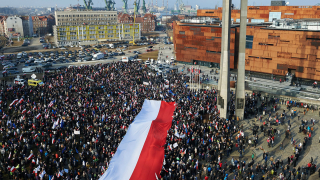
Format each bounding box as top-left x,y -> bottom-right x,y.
4,16 -> 24,37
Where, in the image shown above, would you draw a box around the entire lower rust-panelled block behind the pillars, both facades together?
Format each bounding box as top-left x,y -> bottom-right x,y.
173,19 -> 320,81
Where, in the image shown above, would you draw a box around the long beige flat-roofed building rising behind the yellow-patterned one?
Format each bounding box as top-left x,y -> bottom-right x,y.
55,11 -> 117,26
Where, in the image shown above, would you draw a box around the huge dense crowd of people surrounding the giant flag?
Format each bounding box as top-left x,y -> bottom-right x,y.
0,62 -> 318,180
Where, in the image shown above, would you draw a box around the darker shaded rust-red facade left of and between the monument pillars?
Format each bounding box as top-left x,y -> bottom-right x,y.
173,21 -> 238,69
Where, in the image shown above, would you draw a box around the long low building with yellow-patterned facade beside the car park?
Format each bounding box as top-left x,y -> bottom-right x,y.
53,23 -> 141,45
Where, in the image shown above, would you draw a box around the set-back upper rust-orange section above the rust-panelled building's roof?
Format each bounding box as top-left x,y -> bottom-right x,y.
197,6 -> 320,22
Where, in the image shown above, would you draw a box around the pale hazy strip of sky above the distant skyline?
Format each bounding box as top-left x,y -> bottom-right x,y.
0,0 -> 320,8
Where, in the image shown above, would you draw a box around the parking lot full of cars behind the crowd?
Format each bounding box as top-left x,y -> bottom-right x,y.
1,43 -> 173,82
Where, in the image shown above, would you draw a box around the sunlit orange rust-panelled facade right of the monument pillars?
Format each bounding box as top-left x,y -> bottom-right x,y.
246,26 -> 320,81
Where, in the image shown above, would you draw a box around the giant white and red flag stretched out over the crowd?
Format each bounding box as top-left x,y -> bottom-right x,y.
99,100 -> 175,180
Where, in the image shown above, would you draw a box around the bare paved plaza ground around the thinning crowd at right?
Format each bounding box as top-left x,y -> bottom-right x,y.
159,46 -> 320,179
